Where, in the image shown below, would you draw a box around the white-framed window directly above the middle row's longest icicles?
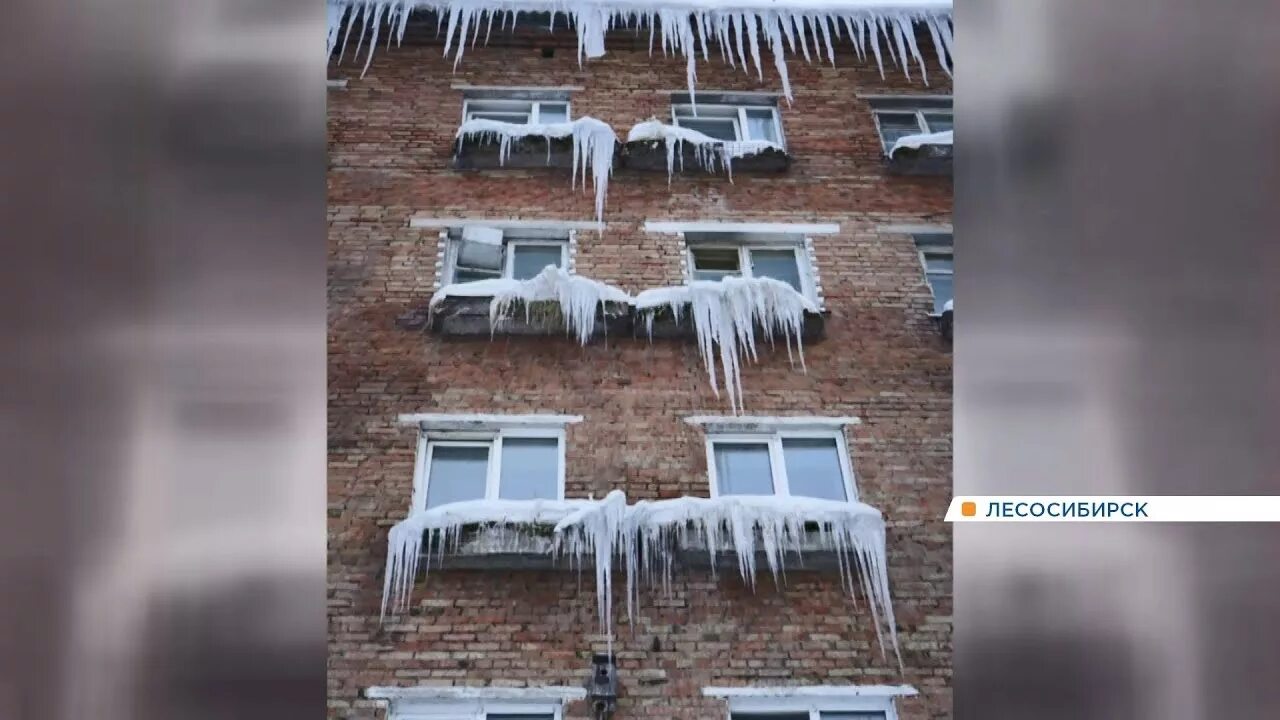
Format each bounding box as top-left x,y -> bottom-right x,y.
685,233 -> 814,300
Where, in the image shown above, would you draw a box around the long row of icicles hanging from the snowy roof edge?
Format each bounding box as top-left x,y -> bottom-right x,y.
328,0 -> 954,101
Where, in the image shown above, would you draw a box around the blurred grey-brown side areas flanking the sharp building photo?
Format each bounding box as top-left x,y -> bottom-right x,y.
0,0 -> 1280,720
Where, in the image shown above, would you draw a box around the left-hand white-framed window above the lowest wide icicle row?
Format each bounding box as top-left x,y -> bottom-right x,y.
417,429 -> 564,509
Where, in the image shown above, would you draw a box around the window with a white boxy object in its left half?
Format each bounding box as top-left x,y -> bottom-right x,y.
448,227 -> 568,283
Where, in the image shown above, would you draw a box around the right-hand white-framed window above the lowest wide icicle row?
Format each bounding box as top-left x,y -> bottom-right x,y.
707,432 -> 858,501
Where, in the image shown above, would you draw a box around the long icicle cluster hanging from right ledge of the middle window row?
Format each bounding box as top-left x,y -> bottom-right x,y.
634,277 -> 818,414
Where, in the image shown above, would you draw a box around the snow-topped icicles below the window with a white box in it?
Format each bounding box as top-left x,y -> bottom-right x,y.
429,265 -> 631,345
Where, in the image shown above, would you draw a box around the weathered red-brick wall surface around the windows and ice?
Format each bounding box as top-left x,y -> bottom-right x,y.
328,20 -> 951,720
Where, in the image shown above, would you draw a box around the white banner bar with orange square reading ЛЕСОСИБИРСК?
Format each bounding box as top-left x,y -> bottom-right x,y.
946,495 -> 1280,523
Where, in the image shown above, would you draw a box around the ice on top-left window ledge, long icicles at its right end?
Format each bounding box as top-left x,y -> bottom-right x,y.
457,118 -> 618,223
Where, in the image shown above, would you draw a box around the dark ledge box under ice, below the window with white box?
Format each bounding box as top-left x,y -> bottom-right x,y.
428,289 -> 631,338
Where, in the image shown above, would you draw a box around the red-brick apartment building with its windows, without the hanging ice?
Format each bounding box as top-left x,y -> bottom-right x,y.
328,0 -> 951,720
